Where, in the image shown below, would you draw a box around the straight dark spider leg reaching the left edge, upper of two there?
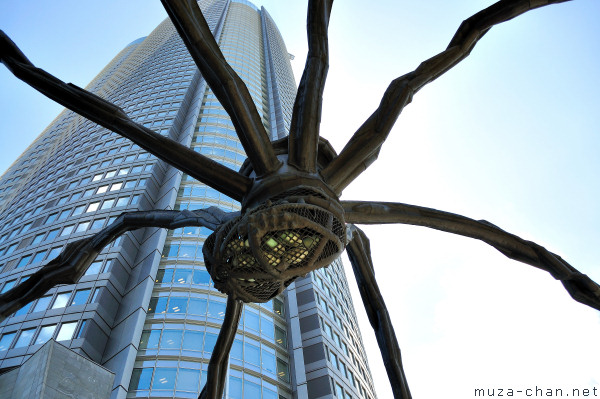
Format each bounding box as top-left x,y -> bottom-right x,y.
0,31 -> 251,201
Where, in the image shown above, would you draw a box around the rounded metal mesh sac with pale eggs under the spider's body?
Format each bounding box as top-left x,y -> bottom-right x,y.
203,197 -> 346,303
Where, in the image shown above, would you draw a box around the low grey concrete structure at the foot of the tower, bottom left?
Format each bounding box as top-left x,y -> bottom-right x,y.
0,340 -> 115,399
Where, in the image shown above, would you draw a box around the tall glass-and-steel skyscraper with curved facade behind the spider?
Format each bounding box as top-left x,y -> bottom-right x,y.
0,0 -> 375,398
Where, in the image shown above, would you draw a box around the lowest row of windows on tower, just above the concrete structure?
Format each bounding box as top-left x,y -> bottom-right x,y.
0,320 -> 85,351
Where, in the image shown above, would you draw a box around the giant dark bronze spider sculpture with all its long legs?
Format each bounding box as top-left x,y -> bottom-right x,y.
0,0 -> 600,398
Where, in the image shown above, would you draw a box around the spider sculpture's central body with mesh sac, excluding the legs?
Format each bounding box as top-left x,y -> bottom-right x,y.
203,138 -> 347,303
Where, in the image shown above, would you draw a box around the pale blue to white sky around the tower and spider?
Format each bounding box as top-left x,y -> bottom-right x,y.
0,0 -> 600,399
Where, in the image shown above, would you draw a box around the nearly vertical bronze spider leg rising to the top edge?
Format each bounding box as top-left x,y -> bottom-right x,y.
288,0 -> 333,173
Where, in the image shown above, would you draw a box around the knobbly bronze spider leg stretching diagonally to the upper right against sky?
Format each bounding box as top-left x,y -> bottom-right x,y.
321,0 -> 568,194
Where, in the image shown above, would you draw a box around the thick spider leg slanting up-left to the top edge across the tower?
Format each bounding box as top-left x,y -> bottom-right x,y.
161,0 -> 281,176
